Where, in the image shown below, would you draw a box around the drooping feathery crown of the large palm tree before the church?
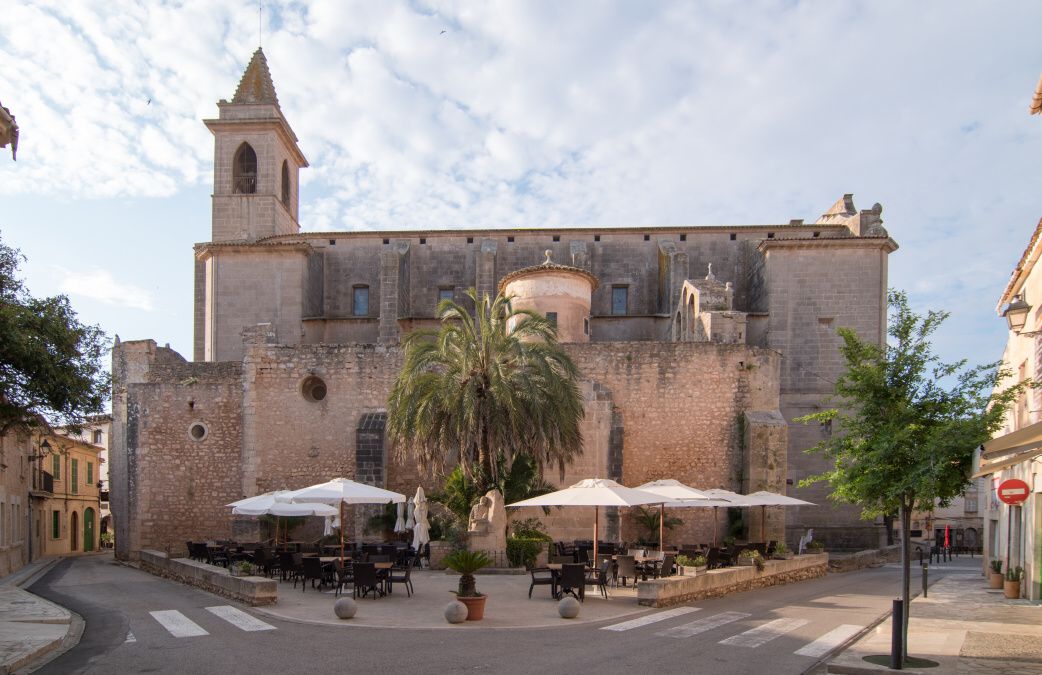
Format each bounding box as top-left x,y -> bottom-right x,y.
388,289 -> 584,484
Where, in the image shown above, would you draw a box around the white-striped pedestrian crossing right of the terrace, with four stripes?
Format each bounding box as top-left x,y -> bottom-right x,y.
600,606 -> 865,658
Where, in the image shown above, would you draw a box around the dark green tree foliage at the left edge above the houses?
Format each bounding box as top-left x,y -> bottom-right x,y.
0,234 -> 109,435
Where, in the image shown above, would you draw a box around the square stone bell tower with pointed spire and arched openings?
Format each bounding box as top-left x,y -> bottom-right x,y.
203,48 -> 307,242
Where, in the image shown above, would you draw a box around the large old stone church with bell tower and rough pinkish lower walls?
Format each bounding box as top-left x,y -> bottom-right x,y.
110,49 -> 897,557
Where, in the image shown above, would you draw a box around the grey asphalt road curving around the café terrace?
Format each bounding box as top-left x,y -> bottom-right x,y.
30,556 -> 978,675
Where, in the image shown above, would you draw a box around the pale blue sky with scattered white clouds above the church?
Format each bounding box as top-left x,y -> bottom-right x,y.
0,0 -> 1042,368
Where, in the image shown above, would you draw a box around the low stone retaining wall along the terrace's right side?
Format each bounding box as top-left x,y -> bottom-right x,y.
637,553 -> 828,607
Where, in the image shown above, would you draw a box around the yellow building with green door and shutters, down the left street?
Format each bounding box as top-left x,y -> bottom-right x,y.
29,433 -> 101,557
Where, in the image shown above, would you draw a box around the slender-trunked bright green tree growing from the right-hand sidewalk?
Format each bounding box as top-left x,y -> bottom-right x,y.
799,291 -> 1029,656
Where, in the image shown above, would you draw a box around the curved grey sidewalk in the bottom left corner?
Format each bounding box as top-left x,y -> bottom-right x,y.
0,558 -> 73,675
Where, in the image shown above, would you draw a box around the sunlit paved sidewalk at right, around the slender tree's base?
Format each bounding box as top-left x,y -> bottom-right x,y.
827,572 -> 1042,675
